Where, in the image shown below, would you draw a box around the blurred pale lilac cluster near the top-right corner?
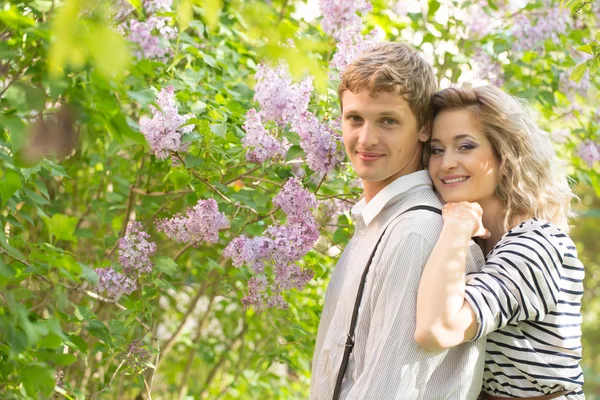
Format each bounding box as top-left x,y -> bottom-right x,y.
513,5 -> 573,51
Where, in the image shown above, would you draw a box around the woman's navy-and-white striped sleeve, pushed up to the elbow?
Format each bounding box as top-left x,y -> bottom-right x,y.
465,225 -> 564,340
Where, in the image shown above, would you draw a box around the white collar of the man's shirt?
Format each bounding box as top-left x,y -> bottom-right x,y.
352,170 -> 432,226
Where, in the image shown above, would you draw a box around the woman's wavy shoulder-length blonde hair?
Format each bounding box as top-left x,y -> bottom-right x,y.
425,85 -> 575,231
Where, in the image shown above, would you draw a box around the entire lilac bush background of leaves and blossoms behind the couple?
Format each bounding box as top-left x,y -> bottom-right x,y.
0,0 -> 600,399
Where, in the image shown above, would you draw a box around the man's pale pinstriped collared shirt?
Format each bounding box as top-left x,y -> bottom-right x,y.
311,171 -> 485,400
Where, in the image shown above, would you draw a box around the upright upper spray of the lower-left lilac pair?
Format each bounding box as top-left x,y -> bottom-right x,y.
119,221 -> 156,277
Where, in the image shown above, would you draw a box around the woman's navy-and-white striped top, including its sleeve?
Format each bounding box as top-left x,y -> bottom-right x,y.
466,218 -> 585,400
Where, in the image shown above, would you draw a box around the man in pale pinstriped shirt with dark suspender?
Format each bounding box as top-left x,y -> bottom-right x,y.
311,43 -> 484,400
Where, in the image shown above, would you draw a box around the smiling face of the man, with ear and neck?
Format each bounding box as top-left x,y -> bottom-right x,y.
342,90 -> 427,201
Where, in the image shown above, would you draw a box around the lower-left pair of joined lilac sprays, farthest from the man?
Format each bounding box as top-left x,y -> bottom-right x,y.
95,221 -> 156,300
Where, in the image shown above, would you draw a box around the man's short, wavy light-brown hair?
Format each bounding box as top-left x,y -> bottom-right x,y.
338,42 -> 437,129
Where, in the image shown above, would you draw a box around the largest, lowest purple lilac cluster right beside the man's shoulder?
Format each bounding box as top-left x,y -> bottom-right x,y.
223,178 -> 319,313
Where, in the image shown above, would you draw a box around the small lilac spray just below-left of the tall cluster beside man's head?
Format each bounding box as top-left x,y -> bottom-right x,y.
242,109 -> 290,164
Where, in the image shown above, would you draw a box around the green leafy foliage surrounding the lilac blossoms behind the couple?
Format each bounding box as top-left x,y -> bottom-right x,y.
0,0 -> 600,399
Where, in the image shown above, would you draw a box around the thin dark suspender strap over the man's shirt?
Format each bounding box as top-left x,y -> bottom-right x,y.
333,205 -> 442,400
